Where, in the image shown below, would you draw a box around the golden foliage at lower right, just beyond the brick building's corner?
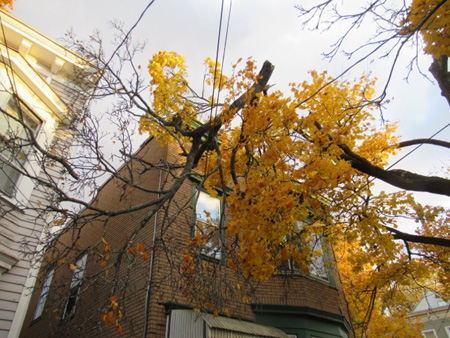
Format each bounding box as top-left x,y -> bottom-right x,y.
336,243 -> 429,338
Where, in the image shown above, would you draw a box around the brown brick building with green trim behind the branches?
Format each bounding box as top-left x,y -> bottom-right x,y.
20,138 -> 353,338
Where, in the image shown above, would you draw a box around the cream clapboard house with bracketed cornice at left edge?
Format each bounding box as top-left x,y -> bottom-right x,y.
0,11 -> 95,338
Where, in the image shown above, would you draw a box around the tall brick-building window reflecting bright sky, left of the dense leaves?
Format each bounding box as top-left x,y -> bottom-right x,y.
194,191 -> 223,259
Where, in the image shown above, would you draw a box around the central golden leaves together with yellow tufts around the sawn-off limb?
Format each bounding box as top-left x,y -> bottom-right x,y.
140,52 -> 396,280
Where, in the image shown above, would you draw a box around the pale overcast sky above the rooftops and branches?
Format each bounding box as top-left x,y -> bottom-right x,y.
9,0 -> 450,209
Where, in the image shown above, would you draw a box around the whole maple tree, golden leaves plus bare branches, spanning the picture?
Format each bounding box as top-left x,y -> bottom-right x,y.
1,1 -> 450,337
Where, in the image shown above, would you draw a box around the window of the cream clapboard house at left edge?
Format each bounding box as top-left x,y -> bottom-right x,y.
0,96 -> 42,197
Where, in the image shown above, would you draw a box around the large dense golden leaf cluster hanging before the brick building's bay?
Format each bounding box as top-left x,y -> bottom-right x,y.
209,68 -> 396,280
